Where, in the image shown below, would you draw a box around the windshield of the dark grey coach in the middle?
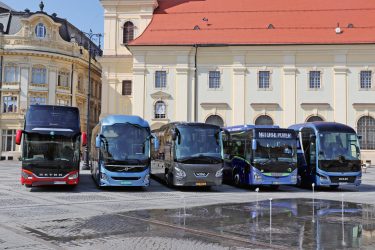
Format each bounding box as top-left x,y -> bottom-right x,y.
176,125 -> 222,161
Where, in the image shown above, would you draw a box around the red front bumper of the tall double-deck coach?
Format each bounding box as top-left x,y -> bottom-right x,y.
21,169 -> 79,187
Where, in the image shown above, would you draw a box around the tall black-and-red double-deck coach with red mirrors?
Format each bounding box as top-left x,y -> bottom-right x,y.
16,105 -> 87,188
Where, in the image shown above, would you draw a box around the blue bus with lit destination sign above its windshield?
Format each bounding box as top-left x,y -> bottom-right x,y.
223,125 -> 298,189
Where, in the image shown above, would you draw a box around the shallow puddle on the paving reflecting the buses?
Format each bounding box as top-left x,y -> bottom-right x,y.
126,199 -> 375,249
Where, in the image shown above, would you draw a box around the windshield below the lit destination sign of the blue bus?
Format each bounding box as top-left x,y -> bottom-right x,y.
254,139 -> 297,162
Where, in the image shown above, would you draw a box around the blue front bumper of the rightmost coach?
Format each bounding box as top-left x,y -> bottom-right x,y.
316,171 -> 362,186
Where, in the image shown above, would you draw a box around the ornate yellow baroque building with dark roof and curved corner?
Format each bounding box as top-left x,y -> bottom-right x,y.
0,3 -> 101,160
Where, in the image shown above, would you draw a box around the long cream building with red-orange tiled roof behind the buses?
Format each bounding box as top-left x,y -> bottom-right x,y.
101,0 -> 375,162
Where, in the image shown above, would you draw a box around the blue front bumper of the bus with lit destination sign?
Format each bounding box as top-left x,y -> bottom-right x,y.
249,168 -> 298,185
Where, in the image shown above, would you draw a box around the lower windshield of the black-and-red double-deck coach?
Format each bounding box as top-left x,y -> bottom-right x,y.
23,133 -> 80,162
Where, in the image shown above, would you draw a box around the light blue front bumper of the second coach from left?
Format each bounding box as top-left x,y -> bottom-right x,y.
100,167 -> 150,187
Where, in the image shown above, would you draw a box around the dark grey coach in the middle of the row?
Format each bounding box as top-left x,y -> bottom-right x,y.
151,122 -> 223,186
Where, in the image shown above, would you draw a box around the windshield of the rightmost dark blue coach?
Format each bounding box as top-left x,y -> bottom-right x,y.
319,132 -> 359,160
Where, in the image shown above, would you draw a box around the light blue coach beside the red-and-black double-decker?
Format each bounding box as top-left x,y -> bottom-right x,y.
90,115 -> 152,188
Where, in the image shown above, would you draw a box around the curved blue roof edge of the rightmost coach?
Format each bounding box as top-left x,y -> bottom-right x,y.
289,122 -> 355,133
